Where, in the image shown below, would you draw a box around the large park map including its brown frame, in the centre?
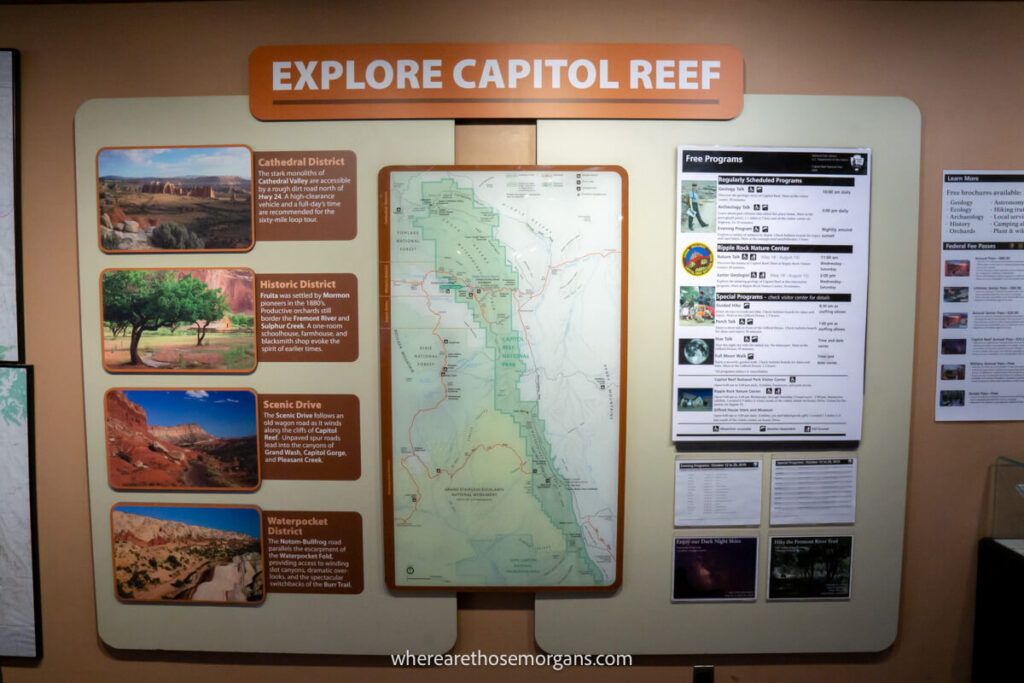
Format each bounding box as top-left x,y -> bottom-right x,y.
380,166 -> 627,591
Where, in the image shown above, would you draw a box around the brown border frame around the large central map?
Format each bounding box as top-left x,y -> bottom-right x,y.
377,164 -> 629,593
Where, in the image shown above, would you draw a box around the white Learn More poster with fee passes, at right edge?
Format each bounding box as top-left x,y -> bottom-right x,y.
935,171 -> 1024,421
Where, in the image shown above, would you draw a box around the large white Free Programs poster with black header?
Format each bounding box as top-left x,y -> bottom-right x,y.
672,145 -> 870,443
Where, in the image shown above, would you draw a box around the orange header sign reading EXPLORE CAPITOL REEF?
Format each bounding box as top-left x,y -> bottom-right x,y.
249,43 -> 743,121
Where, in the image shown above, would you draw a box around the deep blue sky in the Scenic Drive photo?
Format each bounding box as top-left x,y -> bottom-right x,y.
125,389 -> 256,438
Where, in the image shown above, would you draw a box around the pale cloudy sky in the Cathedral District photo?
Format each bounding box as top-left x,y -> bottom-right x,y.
99,146 -> 252,179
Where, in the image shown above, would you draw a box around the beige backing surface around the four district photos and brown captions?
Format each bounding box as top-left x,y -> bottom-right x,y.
75,97 -> 456,654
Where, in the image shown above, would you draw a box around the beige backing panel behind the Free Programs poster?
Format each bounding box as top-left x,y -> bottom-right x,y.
536,95 -> 921,654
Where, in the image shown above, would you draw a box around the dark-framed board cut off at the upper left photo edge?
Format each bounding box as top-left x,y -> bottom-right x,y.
0,49 -> 23,362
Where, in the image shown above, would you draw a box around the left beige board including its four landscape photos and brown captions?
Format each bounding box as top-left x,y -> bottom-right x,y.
75,97 -> 456,654
